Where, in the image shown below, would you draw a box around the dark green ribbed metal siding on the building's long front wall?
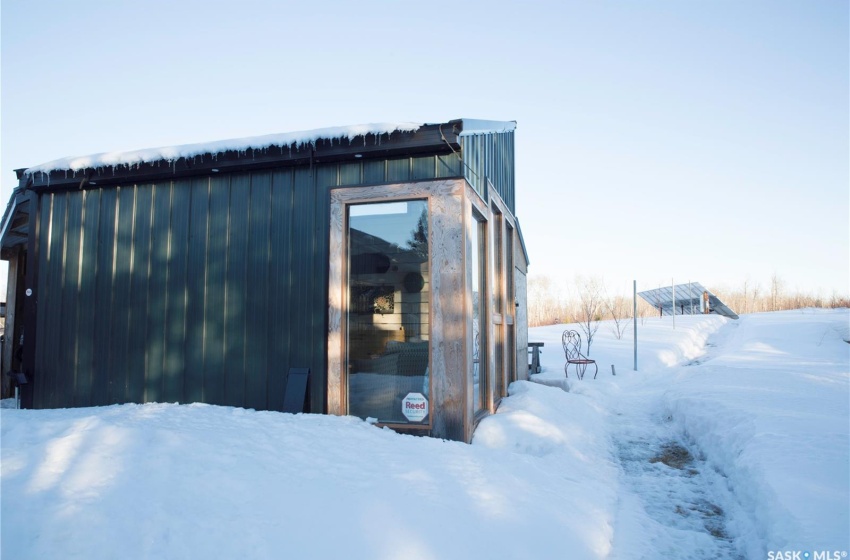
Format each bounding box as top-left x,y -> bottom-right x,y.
34,155 -> 462,412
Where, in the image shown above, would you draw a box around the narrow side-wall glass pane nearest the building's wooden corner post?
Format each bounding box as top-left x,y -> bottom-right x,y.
469,210 -> 487,413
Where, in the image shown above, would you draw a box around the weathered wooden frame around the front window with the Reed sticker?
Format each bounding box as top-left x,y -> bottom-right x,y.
327,179 -> 471,441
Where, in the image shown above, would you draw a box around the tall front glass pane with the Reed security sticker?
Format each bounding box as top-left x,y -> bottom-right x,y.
346,200 -> 430,424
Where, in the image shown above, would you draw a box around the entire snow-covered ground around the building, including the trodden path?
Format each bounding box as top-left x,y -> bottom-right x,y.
0,310 -> 850,560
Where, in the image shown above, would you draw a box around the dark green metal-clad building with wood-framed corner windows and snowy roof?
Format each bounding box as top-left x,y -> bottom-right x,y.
0,119 -> 527,441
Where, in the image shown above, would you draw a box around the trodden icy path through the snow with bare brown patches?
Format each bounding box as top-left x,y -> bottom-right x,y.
611,327 -> 744,560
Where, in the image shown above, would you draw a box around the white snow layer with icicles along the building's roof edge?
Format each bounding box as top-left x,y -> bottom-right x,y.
26,122 -> 422,174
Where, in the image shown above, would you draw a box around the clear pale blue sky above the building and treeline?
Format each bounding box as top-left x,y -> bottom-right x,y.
0,0 -> 850,295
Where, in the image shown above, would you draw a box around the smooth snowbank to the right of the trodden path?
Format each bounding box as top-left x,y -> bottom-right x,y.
666,310 -> 850,550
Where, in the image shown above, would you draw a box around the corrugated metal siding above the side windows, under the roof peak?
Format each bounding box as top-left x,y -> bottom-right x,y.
460,132 -> 516,214
